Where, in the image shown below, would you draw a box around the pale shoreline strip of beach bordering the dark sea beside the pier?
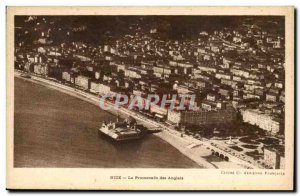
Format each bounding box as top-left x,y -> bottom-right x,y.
14,71 -> 253,169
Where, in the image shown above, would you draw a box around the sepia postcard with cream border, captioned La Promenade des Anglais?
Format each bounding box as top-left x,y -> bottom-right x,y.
7,7 -> 294,190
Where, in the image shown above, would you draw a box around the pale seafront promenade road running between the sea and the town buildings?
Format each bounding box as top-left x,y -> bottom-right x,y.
15,71 -> 258,169
